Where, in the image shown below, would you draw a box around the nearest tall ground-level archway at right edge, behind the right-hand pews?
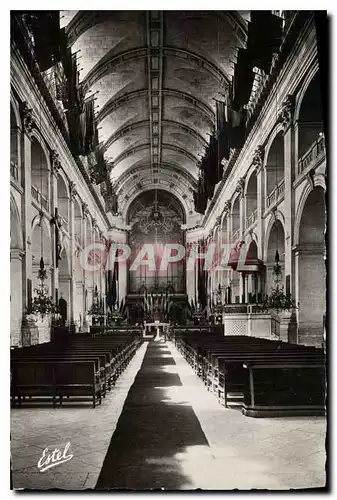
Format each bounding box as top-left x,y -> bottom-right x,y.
297,187 -> 326,346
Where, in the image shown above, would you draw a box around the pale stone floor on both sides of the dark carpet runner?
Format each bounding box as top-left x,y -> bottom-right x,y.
11,343 -> 326,490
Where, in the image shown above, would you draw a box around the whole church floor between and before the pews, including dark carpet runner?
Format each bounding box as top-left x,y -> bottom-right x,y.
11,341 -> 326,490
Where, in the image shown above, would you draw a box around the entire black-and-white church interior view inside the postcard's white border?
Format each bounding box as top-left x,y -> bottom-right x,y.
10,10 -> 328,491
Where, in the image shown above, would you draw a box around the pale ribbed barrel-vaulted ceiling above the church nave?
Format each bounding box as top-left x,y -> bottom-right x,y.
61,11 -> 249,214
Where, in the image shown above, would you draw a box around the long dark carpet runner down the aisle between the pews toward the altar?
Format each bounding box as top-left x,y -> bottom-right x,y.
96,342 -> 211,490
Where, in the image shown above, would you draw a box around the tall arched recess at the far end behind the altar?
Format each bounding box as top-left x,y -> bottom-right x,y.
127,190 -> 186,294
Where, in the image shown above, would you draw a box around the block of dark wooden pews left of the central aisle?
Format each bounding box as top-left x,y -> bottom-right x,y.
11,330 -> 142,408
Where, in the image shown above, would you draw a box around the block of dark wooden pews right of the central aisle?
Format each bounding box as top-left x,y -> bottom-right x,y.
174,329 -> 326,417
